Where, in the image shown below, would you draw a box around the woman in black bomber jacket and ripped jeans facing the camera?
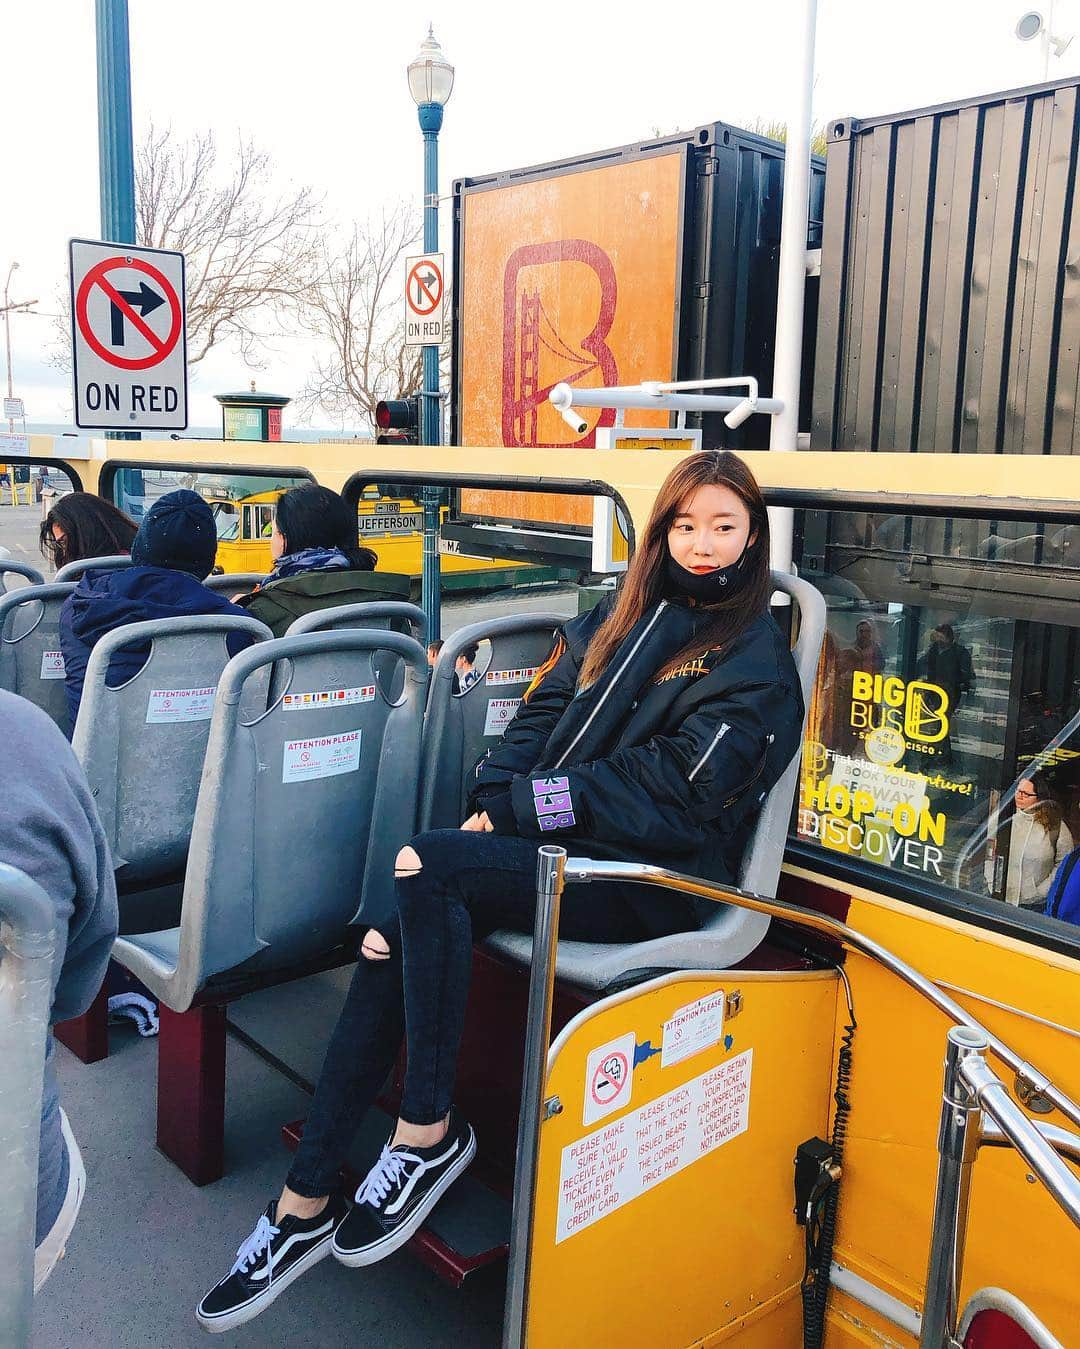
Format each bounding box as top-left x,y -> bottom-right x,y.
197,452 -> 804,1330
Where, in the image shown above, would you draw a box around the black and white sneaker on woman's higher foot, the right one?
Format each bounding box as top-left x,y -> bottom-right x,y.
332,1110 -> 476,1265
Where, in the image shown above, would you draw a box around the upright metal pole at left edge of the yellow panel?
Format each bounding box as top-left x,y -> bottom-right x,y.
503,844 -> 566,1349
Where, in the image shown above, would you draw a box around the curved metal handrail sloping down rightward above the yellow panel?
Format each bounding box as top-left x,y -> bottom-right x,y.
566,857 -> 1080,1126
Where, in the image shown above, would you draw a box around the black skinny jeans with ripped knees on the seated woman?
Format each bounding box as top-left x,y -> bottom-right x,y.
286,830 -> 697,1198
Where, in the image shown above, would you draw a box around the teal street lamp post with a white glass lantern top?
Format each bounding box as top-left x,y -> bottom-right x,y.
409,27 -> 454,642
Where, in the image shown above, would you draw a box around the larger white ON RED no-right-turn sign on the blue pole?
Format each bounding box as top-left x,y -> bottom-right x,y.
70,239 -> 187,430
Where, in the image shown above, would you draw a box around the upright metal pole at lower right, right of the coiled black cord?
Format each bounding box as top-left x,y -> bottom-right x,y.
918,1025 -> 987,1349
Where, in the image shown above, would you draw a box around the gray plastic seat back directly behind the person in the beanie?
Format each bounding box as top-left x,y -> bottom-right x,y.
71,614 -> 271,885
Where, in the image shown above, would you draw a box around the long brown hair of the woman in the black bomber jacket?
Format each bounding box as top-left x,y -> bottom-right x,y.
578,449 -> 770,688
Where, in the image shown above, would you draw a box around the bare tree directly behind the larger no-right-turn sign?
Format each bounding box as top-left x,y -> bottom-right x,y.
135,125 -> 321,366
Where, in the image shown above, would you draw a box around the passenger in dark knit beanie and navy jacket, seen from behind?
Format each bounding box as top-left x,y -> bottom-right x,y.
59,491 -> 248,727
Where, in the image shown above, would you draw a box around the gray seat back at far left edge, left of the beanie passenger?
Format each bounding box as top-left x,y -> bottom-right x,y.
0,581 -> 76,735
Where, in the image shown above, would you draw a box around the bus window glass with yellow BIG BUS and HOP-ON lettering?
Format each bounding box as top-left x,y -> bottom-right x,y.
793,510 -> 1080,936
